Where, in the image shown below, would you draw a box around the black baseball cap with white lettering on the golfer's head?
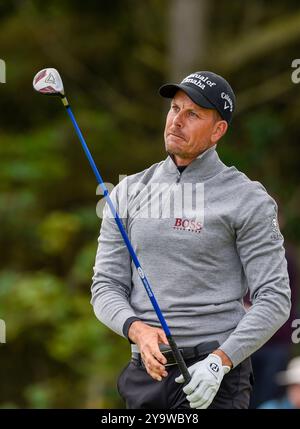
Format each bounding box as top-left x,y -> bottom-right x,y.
159,71 -> 235,124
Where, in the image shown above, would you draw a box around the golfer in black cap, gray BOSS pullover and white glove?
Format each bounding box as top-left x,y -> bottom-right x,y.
92,71 -> 290,409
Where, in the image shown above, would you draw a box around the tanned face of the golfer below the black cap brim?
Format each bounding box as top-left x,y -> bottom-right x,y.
164,90 -> 227,165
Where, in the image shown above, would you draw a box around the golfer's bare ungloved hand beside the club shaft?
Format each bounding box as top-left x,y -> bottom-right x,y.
128,320 -> 169,381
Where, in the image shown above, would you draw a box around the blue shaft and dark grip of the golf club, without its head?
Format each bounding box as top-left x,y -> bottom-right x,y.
62,99 -> 191,383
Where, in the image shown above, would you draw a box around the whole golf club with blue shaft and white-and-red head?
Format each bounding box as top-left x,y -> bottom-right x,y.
33,68 -> 191,383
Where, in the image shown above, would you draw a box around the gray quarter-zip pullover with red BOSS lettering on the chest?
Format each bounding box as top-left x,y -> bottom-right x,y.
91,146 -> 290,366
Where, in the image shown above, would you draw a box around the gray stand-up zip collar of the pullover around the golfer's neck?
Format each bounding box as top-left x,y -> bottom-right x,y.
163,145 -> 225,180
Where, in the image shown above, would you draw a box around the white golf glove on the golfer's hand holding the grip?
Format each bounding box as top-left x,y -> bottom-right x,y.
175,353 -> 230,409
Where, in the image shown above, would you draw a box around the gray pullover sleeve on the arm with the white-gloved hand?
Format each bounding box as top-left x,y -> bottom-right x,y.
220,189 -> 291,366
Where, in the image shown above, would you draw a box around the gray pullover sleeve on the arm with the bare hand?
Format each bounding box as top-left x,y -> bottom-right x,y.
91,184 -> 136,336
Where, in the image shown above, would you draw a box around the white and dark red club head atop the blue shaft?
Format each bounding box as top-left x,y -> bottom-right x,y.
33,68 -> 64,97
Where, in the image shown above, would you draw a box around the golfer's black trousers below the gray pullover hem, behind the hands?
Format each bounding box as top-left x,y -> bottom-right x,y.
117,355 -> 253,409
